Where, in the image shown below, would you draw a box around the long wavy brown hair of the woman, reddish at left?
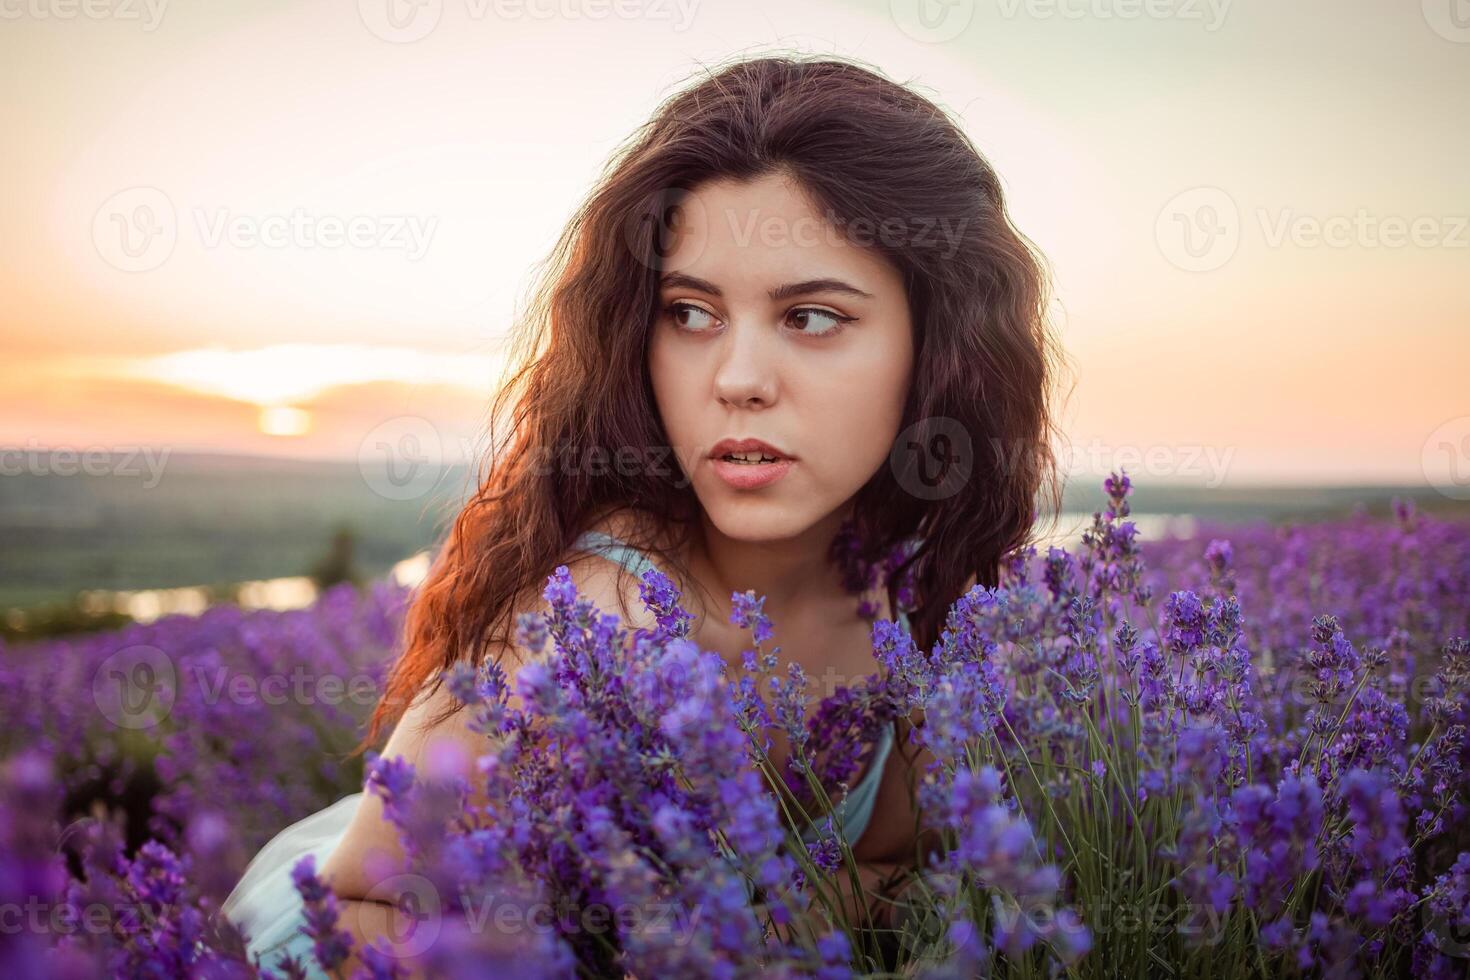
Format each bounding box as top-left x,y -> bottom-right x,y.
357,56 -> 1063,752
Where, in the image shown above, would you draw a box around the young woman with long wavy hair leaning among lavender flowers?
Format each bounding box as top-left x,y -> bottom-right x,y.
226,57 -> 1057,980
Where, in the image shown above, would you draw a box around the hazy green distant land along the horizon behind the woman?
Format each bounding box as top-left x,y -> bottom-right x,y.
0,453 -> 1467,608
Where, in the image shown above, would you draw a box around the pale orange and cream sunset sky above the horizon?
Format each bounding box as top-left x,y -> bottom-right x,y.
0,0 -> 1470,483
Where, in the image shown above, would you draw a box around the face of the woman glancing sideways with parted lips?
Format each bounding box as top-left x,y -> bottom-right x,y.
648,175 -> 913,541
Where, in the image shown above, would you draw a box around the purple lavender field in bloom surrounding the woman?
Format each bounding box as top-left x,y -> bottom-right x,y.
0,478 -> 1470,979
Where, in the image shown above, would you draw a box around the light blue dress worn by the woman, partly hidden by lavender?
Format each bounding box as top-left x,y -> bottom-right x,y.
222,530 -> 910,979
